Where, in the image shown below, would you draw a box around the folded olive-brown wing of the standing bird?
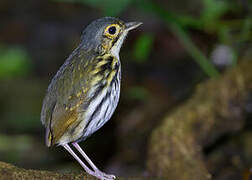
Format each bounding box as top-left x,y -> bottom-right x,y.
41,47 -> 94,146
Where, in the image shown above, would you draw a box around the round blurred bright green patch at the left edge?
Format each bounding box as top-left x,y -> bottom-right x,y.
0,46 -> 31,79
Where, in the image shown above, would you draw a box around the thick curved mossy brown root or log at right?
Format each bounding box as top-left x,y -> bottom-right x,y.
147,61 -> 252,180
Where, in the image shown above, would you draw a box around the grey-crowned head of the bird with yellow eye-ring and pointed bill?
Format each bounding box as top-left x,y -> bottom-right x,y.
81,17 -> 142,56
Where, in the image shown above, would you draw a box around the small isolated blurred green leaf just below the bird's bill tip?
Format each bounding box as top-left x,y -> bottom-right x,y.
134,33 -> 154,63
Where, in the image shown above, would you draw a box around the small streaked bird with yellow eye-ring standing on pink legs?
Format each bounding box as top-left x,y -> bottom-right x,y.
40,17 -> 142,180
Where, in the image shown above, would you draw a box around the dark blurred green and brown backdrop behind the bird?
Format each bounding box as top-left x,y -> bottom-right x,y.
0,0 -> 252,179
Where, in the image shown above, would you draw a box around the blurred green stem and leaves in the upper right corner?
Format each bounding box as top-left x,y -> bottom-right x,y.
136,0 -> 252,77
